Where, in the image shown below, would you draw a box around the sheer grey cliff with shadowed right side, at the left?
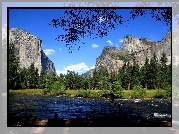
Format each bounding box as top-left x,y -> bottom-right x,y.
4,27 -> 56,73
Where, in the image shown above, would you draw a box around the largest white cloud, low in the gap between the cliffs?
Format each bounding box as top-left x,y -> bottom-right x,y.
56,62 -> 94,75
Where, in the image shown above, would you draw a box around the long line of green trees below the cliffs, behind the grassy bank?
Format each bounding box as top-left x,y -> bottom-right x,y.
8,42 -> 171,95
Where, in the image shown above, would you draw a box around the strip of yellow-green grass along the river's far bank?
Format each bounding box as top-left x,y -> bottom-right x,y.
9,89 -> 169,98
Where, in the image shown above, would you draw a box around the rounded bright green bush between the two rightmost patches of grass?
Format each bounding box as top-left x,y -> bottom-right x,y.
132,85 -> 146,98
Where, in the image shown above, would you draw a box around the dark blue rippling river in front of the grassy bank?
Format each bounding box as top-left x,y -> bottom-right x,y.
9,95 -> 172,121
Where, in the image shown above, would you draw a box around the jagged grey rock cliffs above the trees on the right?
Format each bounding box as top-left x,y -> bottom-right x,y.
95,31 -> 171,72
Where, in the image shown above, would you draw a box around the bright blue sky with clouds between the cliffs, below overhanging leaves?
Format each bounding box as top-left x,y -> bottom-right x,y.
9,9 -> 171,74
